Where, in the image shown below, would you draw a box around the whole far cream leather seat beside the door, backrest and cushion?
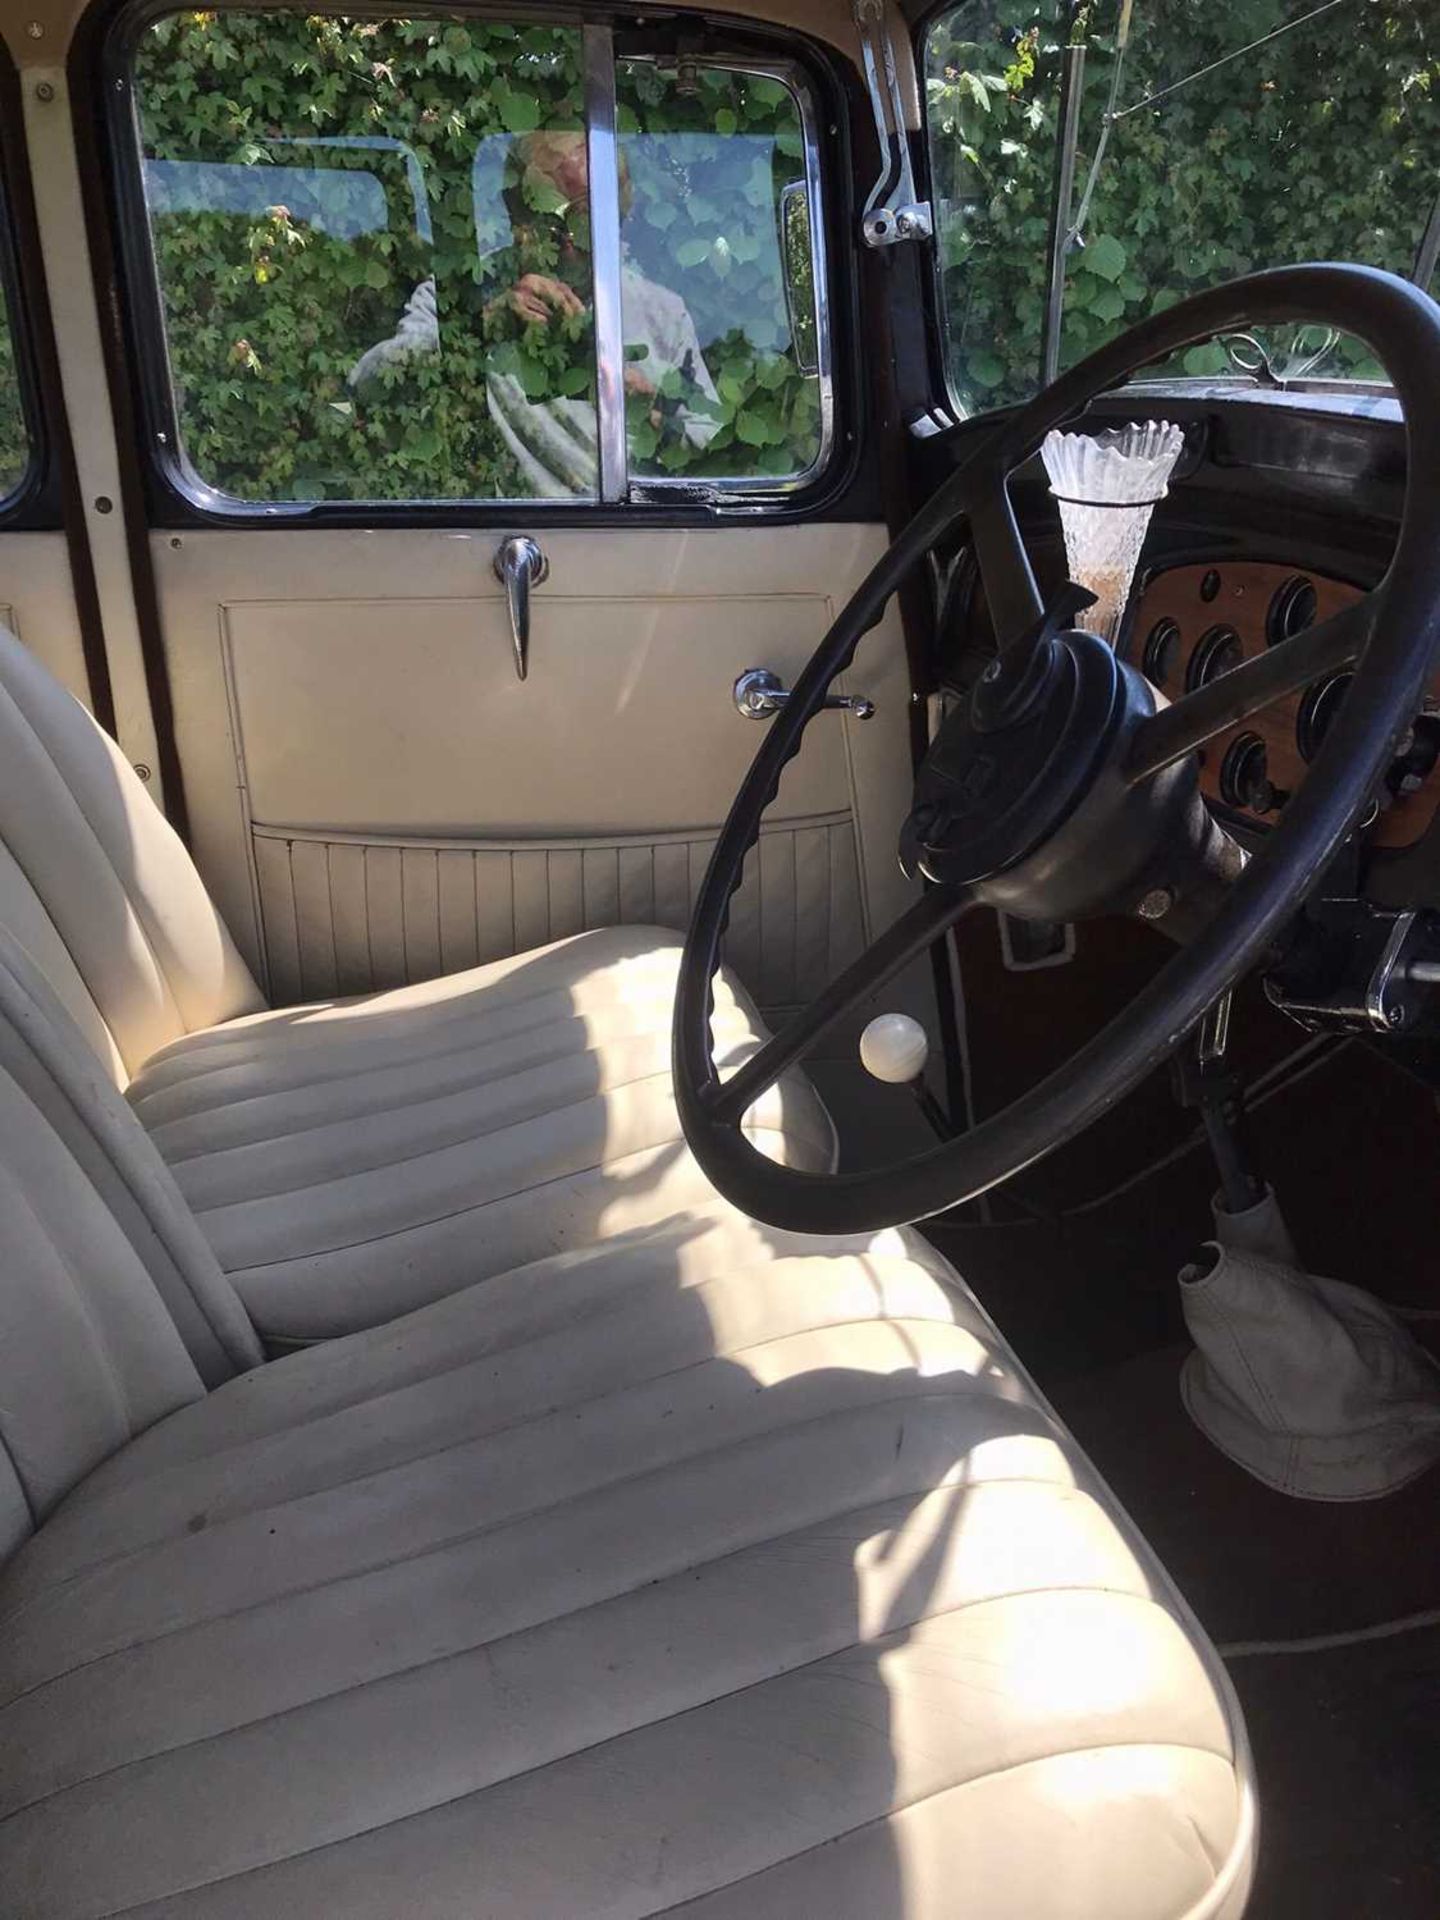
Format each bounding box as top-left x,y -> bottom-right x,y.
0,630 -> 833,1342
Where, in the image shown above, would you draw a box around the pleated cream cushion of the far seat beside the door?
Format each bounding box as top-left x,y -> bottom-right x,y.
129,927 -> 833,1340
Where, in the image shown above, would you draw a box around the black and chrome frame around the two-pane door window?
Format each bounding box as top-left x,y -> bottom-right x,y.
115,11 -> 837,524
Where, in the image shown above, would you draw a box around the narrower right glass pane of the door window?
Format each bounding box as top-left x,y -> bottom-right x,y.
616,58 -> 829,484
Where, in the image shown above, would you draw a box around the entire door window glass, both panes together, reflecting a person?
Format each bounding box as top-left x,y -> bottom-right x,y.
132,12 -> 829,507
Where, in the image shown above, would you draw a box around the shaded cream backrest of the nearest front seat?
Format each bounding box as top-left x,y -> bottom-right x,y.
0,929 -> 263,1561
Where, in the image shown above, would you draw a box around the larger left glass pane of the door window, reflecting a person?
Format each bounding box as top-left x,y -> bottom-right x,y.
134,12 -> 597,503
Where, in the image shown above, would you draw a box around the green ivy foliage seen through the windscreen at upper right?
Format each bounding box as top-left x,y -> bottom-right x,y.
925,0 -> 1440,411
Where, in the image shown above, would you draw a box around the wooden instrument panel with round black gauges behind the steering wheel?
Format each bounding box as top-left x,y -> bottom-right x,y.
1121,559 -> 1440,851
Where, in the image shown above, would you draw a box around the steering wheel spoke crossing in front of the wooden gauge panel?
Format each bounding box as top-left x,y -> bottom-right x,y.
1125,588 -> 1382,787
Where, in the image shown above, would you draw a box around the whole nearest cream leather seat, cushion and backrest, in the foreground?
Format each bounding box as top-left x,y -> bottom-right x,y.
0,975 -> 1254,1920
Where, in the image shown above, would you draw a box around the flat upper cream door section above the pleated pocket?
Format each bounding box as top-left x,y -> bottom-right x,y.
223,583 -> 849,839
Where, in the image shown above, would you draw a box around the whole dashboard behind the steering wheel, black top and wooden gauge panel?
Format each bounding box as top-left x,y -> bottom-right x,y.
916,382 -> 1440,1059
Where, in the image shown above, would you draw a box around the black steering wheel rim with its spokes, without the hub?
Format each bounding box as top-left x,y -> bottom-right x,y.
674,265 -> 1440,1233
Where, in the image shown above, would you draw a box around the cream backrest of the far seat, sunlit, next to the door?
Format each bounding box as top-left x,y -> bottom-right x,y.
0,628 -> 265,1087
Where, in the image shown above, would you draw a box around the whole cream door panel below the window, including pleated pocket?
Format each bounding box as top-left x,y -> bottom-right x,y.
154,520 -> 910,1010
